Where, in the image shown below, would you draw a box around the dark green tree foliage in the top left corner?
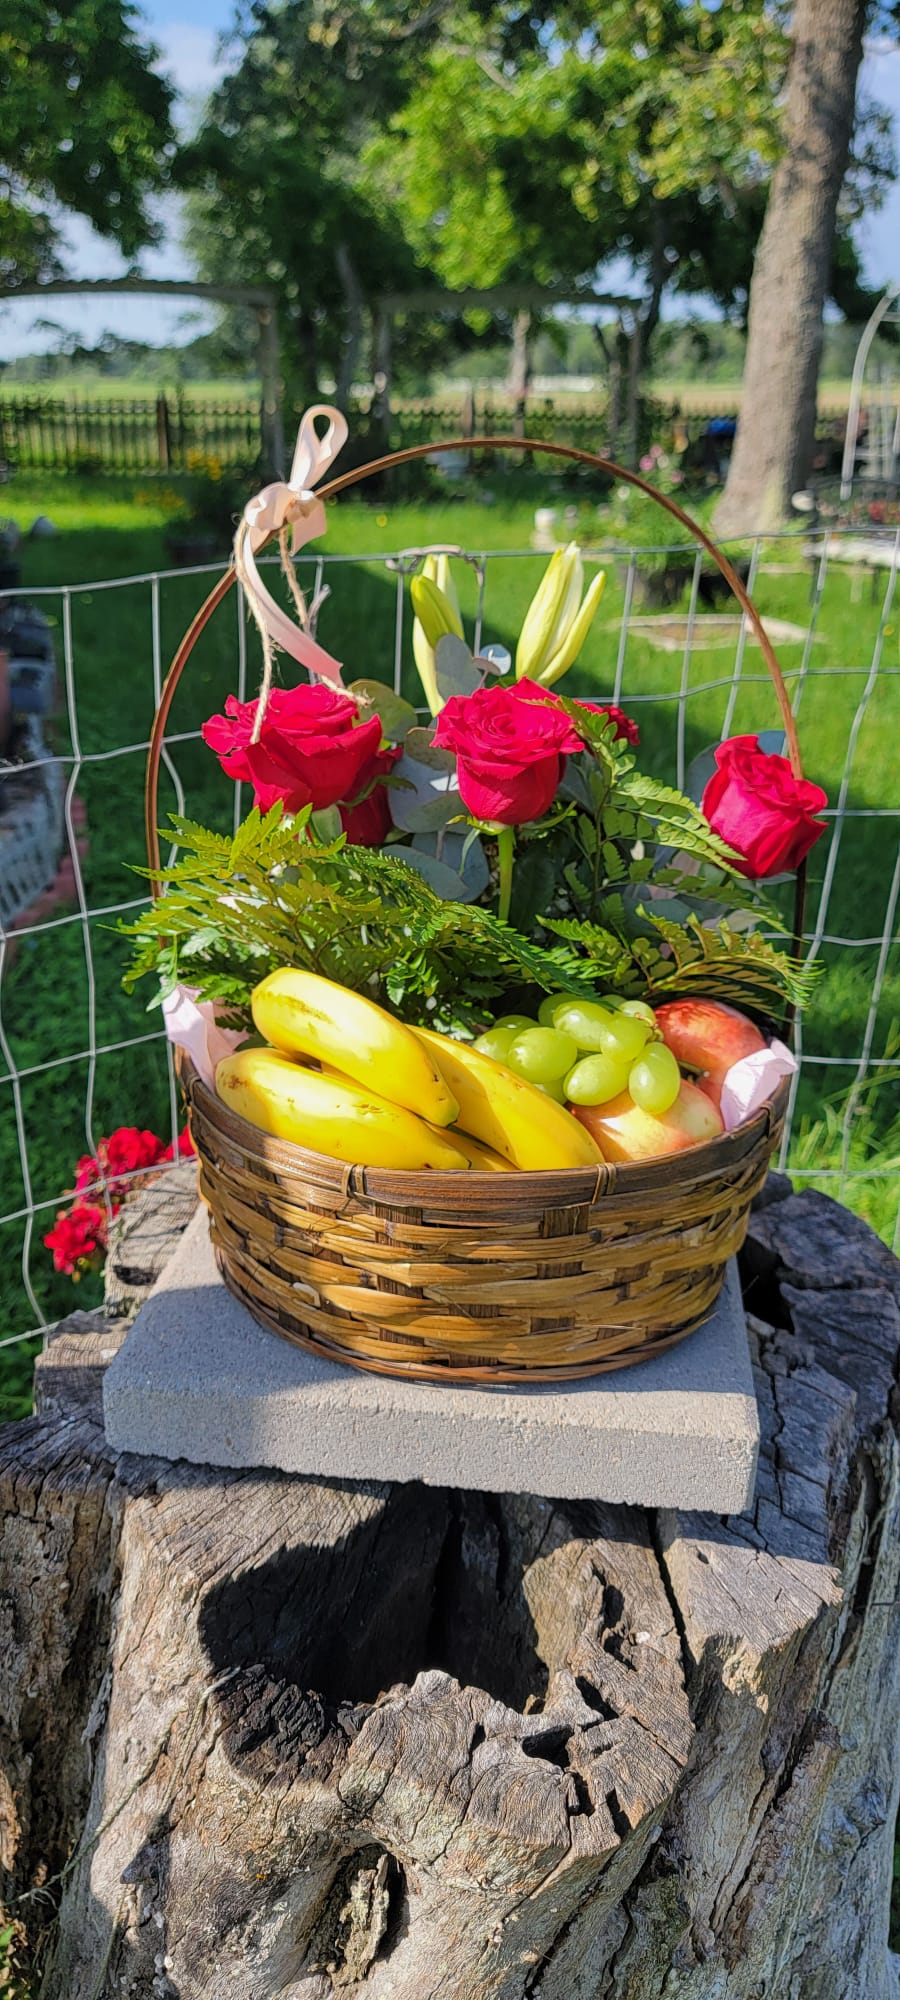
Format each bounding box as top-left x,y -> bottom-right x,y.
0,0 -> 174,284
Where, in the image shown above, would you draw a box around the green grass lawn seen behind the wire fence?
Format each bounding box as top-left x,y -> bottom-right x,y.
0,476 -> 900,1414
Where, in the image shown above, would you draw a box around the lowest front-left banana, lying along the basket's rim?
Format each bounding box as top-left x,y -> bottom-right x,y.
216,1048 -> 472,1174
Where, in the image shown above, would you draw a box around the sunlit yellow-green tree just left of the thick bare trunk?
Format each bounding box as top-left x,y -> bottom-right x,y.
370,0 -> 784,456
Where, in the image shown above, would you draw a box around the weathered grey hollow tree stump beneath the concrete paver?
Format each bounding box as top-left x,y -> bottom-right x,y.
0,1176 -> 900,2000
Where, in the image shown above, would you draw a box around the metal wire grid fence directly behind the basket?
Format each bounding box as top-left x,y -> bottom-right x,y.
0,530 -> 900,1346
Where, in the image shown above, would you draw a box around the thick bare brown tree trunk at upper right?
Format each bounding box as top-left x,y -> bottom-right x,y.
716,0 -> 868,536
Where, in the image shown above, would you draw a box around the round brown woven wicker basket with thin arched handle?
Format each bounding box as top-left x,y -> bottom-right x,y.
146,438 -> 804,1382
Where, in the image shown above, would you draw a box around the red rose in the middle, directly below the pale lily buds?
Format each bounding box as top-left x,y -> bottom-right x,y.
434,680 -> 584,826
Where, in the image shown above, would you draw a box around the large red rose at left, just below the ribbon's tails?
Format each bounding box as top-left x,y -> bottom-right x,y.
200,682 -> 382,812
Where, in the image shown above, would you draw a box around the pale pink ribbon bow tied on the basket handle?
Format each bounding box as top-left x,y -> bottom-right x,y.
234,402 -> 348,704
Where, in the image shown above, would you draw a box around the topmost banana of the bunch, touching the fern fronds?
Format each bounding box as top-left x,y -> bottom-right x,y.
252,968 -> 458,1126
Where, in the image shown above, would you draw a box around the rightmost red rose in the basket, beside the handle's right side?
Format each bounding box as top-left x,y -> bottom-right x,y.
702,736 -> 828,880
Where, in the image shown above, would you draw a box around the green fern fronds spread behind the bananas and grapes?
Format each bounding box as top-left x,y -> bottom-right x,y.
120,806 -> 820,1028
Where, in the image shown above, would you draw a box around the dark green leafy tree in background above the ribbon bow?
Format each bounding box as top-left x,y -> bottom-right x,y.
178,0 -> 450,400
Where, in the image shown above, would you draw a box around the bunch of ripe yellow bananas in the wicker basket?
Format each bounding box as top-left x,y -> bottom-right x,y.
216,970 -> 600,1172
